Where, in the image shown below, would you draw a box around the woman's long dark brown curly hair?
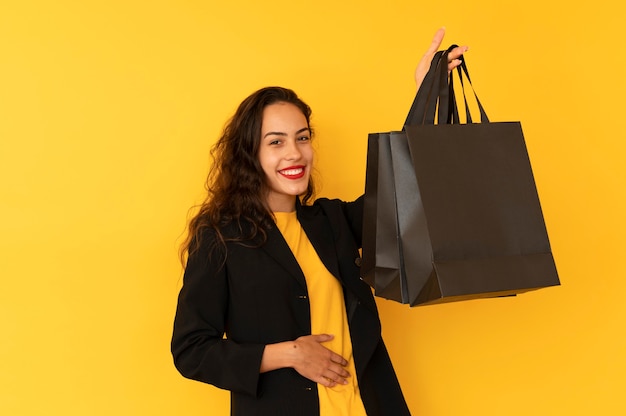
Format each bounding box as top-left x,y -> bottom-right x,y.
180,87 -> 314,263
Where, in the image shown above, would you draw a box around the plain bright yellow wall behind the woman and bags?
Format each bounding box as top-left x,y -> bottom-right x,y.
0,0 -> 626,416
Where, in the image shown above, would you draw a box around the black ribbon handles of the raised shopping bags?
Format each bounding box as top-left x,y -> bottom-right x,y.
404,45 -> 489,126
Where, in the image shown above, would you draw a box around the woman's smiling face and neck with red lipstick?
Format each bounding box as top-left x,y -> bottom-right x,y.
259,102 -> 313,212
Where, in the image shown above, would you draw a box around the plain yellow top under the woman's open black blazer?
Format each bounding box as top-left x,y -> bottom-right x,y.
274,212 -> 366,416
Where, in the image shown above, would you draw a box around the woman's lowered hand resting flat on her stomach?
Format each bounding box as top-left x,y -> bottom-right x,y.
260,334 -> 350,387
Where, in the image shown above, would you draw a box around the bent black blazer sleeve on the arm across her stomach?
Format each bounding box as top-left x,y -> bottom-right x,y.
171,232 -> 265,396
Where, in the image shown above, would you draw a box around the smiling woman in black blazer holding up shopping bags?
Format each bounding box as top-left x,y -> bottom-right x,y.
172,29 -> 467,416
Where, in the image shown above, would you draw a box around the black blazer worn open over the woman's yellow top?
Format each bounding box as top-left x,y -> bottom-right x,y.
172,198 -> 409,416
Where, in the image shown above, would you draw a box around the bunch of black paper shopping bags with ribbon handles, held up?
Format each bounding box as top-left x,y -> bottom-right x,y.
362,46 -> 560,306
